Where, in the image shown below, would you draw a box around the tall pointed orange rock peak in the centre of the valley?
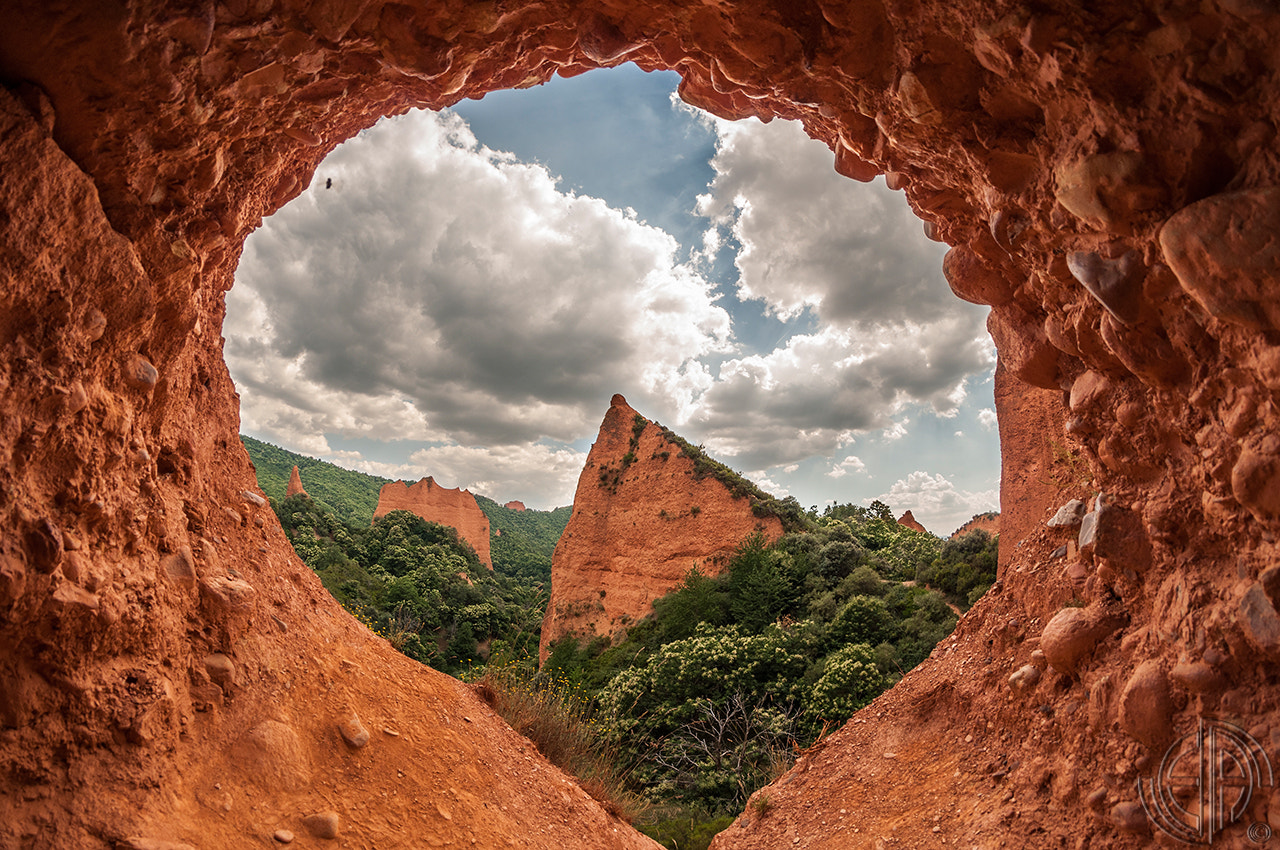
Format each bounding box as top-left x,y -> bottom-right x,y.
540,396 -> 782,661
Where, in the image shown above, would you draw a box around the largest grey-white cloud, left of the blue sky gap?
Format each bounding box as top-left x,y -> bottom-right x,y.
224,111 -> 730,491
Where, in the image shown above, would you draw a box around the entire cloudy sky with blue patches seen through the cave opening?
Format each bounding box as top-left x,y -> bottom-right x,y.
224,67 -> 1000,534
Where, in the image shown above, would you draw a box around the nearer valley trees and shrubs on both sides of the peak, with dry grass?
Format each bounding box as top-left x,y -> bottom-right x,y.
244,437 -> 997,850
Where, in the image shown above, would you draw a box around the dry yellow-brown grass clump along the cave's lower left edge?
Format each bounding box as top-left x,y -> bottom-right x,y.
472,666 -> 648,823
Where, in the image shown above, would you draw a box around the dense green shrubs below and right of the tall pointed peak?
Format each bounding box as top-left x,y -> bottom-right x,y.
529,503 -> 996,846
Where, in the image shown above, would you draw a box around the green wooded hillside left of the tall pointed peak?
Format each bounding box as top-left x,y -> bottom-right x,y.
242,437 -> 571,673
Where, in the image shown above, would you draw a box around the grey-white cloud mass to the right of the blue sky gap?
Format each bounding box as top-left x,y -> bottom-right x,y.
690,112 -> 993,466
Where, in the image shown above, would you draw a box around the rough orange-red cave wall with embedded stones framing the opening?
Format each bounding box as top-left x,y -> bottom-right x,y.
0,0 -> 1280,850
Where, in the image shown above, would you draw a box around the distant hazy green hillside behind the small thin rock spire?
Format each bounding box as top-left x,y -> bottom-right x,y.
241,434 -> 389,526
